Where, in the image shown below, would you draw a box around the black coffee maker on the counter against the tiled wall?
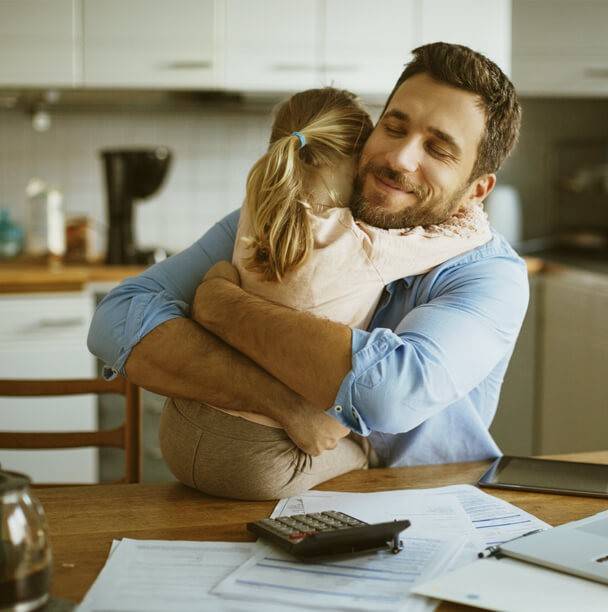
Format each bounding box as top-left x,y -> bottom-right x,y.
100,147 -> 172,265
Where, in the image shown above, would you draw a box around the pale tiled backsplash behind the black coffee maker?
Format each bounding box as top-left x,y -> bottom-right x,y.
0,108 -> 270,251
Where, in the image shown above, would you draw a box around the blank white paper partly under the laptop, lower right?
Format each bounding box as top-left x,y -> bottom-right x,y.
412,559 -> 608,612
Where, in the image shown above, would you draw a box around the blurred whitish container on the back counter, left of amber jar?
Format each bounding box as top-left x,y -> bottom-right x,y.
25,179 -> 65,257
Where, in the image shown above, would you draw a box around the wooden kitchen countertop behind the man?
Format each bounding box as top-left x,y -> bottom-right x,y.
0,257 -> 545,293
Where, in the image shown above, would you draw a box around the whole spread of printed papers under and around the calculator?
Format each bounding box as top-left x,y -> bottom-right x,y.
79,485 -> 547,612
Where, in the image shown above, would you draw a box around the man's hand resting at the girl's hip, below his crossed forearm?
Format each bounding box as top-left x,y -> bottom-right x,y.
280,402 -> 350,457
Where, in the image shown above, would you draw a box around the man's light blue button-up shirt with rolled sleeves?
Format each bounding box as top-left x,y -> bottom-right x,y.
88,210 -> 528,466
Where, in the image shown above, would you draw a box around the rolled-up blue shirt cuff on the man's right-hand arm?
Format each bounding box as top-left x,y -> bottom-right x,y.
326,328 -> 402,436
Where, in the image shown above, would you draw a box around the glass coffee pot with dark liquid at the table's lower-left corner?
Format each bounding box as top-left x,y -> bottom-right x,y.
0,471 -> 52,612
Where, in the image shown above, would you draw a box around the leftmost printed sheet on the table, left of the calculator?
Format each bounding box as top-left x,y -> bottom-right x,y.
78,539 -> 270,612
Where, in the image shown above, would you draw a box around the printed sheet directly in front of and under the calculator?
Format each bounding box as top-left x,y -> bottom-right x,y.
213,538 -> 464,611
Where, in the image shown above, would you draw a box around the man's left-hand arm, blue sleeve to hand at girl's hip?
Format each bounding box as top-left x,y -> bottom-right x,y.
88,211 -> 348,455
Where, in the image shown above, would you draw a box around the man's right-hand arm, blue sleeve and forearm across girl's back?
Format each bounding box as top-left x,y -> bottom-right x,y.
194,257 -> 528,434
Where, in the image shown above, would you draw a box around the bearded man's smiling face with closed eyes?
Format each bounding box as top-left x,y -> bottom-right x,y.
351,73 -> 493,228
